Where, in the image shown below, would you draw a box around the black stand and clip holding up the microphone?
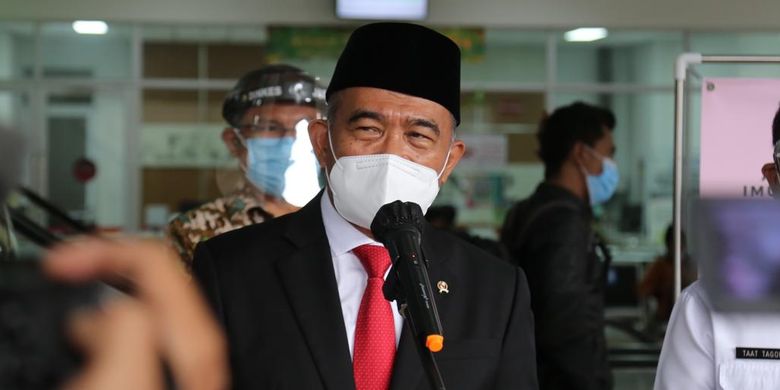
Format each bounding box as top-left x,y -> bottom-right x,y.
382,259 -> 447,390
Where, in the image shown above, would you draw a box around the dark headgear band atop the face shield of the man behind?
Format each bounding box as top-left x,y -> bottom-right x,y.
222,64 -> 325,126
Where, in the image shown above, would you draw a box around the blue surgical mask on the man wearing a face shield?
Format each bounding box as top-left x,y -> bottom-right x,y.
246,137 -> 295,198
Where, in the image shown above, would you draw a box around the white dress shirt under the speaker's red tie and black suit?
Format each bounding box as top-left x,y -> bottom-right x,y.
320,190 -> 403,356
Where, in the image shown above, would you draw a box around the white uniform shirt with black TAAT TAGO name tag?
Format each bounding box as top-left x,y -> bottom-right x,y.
655,282 -> 780,390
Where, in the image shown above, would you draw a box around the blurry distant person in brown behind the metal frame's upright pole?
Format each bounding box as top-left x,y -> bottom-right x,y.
638,225 -> 696,324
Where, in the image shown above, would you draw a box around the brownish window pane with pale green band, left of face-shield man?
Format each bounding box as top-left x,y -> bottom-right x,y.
140,89 -> 236,229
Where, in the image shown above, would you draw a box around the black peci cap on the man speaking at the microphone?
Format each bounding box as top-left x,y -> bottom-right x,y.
326,23 -> 460,124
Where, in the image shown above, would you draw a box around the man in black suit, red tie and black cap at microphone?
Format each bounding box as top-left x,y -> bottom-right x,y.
193,23 -> 537,390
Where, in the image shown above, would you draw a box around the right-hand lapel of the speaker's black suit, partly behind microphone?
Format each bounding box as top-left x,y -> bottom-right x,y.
390,224 -> 453,390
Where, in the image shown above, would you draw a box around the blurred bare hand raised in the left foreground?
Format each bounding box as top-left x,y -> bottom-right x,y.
44,239 -> 229,390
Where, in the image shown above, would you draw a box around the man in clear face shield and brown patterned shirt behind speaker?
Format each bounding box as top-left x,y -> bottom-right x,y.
168,64 -> 325,269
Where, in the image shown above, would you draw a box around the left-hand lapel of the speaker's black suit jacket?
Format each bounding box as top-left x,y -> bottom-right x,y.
277,194 -> 355,389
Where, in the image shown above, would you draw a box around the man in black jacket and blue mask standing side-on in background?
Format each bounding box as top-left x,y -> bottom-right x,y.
501,102 -> 619,389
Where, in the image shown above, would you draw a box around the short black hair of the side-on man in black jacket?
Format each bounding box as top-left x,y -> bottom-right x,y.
537,102 -> 616,179
